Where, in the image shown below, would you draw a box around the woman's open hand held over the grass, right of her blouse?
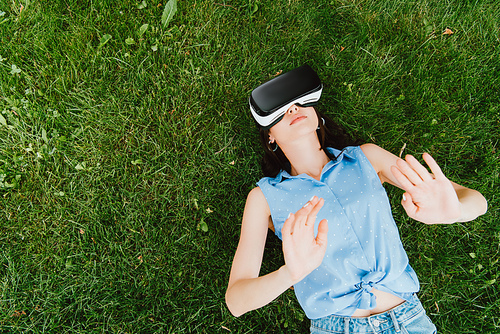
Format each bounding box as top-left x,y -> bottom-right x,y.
391,153 -> 461,224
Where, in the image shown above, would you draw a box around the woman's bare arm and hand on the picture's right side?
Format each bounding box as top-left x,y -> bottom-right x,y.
361,144 -> 488,224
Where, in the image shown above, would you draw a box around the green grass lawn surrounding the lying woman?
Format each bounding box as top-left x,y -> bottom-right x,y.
0,0 -> 500,333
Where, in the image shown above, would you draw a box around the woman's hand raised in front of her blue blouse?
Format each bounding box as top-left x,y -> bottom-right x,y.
281,196 -> 328,284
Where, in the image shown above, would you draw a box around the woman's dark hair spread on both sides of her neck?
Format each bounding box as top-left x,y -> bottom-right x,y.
259,108 -> 361,177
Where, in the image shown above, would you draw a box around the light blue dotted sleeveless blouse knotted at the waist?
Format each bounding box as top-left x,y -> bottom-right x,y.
257,147 -> 419,319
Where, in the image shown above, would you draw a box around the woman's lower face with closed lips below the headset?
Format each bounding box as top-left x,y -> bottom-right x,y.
269,104 -> 318,146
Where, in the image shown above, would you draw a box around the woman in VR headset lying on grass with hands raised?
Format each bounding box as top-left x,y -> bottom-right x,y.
226,65 -> 487,333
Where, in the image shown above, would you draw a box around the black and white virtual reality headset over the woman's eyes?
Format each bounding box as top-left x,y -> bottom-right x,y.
249,65 -> 323,129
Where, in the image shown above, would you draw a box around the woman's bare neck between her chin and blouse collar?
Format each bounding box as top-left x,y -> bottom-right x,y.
280,134 -> 330,180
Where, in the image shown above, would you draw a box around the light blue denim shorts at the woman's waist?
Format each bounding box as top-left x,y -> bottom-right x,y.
311,294 -> 437,334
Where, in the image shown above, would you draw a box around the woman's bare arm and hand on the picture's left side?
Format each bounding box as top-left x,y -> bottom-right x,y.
226,187 -> 328,316
